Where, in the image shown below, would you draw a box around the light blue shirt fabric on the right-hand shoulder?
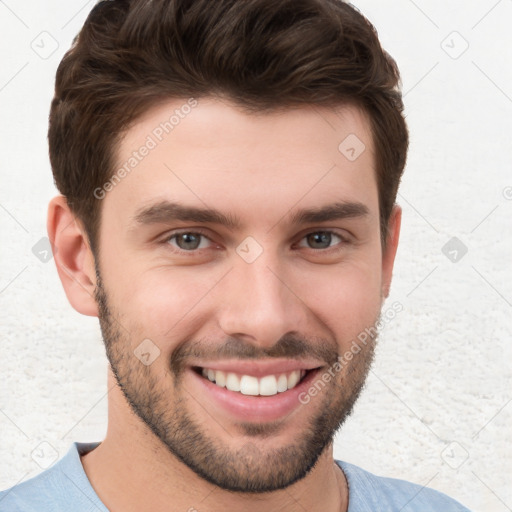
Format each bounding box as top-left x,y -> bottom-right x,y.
335,460 -> 470,512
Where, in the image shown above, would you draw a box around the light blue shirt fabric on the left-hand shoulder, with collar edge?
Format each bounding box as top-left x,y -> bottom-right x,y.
0,443 -> 106,512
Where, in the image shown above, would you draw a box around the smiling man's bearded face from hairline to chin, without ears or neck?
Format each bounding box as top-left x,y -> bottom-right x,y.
96,99 -> 392,492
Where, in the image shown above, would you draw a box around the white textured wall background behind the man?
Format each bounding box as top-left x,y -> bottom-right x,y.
0,0 -> 512,512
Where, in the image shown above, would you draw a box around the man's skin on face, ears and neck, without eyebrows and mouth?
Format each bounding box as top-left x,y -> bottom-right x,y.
48,98 -> 401,512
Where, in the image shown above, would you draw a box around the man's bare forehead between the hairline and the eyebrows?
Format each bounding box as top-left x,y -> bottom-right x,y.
103,98 -> 378,228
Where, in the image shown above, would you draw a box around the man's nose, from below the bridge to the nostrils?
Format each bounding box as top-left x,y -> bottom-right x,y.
218,252 -> 309,348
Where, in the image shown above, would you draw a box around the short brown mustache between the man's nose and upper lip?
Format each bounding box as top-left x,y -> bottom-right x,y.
170,332 -> 338,375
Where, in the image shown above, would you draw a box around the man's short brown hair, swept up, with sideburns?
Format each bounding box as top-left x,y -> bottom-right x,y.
48,0 -> 408,254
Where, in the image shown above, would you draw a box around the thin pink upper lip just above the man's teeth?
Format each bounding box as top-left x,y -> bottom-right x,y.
192,359 -> 322,377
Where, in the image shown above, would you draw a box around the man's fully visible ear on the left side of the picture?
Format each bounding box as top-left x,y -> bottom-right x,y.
47,196 -> 98,316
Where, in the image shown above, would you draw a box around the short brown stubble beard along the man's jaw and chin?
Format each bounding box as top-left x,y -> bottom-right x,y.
95,268 -> 378,493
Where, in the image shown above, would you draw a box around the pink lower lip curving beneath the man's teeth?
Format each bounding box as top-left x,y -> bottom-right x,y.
190,368 -> 320,422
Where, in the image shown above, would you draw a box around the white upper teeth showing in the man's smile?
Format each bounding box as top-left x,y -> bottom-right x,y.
202,368 -> 306,396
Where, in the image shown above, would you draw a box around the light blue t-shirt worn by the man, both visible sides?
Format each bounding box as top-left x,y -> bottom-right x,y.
0,443 -> 469,512
